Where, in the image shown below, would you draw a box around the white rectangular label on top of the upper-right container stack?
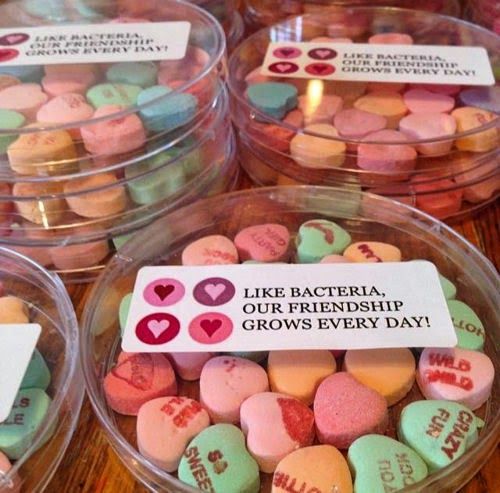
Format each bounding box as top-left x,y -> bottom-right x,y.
261,42 -> 495,86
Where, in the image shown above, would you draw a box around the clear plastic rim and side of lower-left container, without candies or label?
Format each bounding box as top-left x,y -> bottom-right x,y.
0,247 -> 84,493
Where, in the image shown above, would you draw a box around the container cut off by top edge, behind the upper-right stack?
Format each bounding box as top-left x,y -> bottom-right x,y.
244,0 -> 460,31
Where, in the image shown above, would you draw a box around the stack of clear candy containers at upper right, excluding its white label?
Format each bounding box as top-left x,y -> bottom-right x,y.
228,7 -> 500,219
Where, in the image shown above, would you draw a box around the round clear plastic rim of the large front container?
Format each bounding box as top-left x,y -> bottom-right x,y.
80,186 -> 500,493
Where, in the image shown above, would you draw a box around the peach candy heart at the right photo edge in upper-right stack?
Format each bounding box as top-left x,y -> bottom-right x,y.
452,107 -> 498,152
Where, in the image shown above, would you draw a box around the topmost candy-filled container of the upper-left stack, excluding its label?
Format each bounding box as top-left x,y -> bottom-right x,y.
0,0 -> 225,176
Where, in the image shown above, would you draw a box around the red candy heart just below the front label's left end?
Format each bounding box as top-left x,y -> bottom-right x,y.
103,352 -> 177,416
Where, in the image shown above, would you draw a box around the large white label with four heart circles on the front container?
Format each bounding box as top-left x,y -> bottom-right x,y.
122,261 -> 457,352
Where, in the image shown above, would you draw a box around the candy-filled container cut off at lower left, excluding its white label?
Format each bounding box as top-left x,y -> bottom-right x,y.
0,247 -> 84,493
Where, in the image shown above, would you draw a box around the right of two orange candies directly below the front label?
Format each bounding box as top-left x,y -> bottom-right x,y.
344,348 -> 415,406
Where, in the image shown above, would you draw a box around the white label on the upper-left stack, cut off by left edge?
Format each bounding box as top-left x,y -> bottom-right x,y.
0,21 -> 191,68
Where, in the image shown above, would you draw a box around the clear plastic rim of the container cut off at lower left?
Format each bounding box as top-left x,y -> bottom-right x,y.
0,246 -> 85,491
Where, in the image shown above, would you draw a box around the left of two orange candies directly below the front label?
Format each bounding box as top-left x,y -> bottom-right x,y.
267,350 -> 336,406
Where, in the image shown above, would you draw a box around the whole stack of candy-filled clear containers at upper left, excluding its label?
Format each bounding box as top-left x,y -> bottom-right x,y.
0,0 -> 238,281
